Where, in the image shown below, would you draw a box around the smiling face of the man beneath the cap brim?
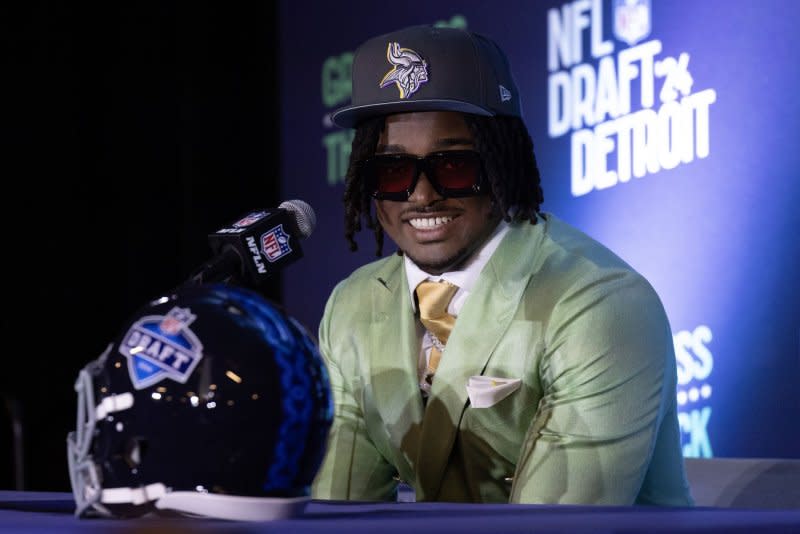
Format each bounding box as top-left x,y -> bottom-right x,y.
367,111 -> 501,274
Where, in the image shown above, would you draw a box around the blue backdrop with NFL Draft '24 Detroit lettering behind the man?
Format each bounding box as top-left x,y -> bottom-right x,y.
280,0 -> 800,457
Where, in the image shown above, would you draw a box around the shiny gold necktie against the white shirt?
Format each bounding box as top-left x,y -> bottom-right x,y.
416,282 -> 458,390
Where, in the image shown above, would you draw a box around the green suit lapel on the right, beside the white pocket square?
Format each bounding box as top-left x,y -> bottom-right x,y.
417,222 -> 544,500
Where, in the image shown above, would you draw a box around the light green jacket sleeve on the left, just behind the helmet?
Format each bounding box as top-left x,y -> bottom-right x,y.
311,283 -> 397,501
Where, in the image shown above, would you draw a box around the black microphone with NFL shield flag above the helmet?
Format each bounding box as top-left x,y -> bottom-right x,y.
183,200 -> 317,287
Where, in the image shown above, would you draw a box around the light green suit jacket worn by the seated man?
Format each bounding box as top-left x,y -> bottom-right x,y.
312,215 -> 692,505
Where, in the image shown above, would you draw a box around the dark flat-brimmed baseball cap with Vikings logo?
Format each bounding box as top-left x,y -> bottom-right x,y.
331,25 -> 522,128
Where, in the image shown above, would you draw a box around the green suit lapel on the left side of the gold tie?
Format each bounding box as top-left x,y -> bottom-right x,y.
369,258 -> 423,482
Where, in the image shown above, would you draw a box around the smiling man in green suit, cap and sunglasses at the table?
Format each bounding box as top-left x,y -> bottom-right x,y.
313,22 -> 692,505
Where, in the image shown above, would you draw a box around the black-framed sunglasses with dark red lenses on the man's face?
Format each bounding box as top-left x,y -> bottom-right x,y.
360,150 -> 485,200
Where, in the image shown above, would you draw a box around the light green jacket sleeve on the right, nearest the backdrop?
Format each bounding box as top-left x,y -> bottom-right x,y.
510,272 -> 676,505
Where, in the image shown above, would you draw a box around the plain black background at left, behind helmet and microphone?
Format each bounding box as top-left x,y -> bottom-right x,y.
0,1 -> 281,491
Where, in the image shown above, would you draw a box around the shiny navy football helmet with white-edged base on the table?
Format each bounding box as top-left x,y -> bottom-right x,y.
67,286 -> 333,520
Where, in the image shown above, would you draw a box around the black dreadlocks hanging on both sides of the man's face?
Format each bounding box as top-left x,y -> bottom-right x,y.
343,113 -> 544,256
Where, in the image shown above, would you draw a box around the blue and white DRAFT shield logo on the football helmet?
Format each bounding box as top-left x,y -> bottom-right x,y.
119,306 -> 203,389
